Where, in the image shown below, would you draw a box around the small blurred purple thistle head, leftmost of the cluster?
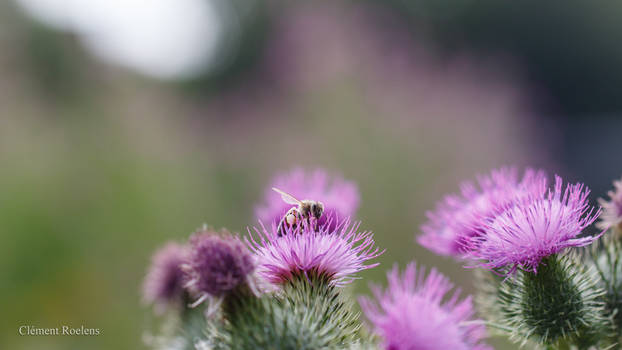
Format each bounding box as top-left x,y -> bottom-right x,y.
143,242 -> 188,309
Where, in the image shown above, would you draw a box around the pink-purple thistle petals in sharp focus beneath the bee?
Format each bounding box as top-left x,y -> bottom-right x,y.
247,220 -> 384,286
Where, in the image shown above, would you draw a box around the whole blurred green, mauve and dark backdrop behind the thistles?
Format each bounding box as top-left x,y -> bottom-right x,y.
0,0 -> 622,350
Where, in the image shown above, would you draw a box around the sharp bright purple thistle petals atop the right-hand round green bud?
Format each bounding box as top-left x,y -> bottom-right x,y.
474,176 -> 602,273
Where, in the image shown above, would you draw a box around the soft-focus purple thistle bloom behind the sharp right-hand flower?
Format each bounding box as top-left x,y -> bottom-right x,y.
417,168 -> 546,257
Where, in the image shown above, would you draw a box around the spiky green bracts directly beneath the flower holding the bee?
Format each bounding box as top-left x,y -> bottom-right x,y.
214,275 -> 360,350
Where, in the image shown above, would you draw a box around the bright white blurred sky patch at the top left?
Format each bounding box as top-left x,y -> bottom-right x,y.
16,0 -> 223,79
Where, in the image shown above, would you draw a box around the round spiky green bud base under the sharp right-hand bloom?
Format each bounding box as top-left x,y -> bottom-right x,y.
497,256 -> 608,348
